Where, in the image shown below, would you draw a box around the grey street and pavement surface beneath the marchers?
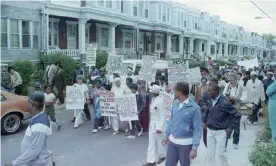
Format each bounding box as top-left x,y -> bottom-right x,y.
1,108 -> 263,166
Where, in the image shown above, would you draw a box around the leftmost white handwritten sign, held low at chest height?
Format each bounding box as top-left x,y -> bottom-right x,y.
65,86 -> 84,109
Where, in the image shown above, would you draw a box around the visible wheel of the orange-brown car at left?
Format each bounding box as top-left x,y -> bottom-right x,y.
1,113 -> 22,134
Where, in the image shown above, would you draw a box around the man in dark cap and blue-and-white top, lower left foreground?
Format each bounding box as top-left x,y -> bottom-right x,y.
5,91 -> 53,166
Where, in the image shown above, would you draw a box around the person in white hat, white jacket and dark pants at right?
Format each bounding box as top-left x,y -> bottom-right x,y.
245,71 -> 265,125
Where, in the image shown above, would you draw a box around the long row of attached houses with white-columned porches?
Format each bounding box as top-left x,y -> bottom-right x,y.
1,0 -> 268,62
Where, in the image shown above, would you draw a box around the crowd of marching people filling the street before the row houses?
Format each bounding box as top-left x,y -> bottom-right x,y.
4,58 -> 276,166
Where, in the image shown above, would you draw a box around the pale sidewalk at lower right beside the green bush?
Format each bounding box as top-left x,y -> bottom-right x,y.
159,119 -> 264,166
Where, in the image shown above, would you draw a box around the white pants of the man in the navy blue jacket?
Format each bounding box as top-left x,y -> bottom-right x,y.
207,129 -> 229,166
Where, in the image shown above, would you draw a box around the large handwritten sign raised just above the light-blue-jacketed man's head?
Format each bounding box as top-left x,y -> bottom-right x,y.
168,60 -> 189,85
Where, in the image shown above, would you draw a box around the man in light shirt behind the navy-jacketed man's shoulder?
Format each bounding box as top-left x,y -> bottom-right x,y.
223,73 -> 243,149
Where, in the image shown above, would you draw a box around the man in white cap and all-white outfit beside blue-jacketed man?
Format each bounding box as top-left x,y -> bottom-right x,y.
143,85 -> 166,166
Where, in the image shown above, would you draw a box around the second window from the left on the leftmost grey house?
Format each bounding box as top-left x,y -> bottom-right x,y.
10,20 -> 19,48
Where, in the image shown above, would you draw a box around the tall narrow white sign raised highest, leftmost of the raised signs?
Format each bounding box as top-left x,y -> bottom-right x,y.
86,43 -> 97,67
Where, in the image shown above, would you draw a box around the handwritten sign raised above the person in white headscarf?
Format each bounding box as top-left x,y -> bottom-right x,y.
107,54 -> 123,74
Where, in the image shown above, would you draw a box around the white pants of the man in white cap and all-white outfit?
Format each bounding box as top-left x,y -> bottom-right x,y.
147,130 -> 166,163
